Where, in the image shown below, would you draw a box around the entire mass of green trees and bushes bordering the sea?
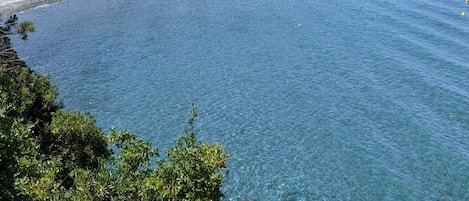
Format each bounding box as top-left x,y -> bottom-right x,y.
0,16 -> 228,200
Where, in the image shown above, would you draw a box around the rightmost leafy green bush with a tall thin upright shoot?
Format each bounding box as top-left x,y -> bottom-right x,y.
153,105 -> 228,200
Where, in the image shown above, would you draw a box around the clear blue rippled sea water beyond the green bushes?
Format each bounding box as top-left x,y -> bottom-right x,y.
14,0 -> 469,201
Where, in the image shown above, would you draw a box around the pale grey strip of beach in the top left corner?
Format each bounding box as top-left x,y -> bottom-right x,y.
0,0 -> 62,17
